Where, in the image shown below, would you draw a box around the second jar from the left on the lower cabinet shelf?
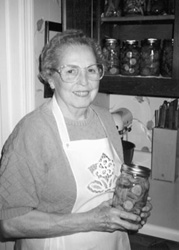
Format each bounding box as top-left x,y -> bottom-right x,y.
120,40 -> 140,76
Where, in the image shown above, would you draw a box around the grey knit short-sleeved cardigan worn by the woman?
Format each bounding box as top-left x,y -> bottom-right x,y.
0,98 -> 123,219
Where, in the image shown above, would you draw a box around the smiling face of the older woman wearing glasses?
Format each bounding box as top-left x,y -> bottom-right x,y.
53,45 -> 99,119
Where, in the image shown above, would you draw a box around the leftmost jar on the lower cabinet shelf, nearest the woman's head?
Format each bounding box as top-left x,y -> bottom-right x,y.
103,38 -> 119,75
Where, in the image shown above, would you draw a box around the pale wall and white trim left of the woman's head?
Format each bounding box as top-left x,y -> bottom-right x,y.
0,0 -> 61,250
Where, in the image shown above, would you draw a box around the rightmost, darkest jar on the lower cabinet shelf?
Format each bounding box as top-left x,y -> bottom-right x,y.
161,39 -> 174,77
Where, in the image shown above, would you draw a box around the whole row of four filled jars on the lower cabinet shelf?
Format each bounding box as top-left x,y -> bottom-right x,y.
102,38 -> 174,77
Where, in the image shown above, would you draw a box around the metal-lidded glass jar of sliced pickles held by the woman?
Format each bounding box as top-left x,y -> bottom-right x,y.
113,164 -> 151,214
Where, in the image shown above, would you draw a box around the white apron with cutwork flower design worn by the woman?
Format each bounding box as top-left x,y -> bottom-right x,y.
44,98 -> 130,250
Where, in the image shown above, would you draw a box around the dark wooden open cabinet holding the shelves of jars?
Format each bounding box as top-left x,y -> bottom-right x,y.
96,0 -> 179,98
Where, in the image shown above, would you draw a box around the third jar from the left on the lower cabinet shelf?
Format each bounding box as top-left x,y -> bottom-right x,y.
140,38 -> 161,76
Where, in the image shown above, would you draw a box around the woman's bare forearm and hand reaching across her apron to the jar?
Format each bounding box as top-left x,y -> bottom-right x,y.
0,200 -> 141,241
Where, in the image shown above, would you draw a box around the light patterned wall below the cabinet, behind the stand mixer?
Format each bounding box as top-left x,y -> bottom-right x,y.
95,93 -> 171,168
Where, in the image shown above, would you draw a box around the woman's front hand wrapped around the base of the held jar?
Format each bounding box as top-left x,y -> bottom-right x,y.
88,200 -> 141,232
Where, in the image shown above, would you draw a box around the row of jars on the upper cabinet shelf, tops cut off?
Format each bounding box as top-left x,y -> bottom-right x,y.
102,0 -> 175,17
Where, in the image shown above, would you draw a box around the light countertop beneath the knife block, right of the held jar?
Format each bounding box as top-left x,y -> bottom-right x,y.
139,178 -> 179,242
